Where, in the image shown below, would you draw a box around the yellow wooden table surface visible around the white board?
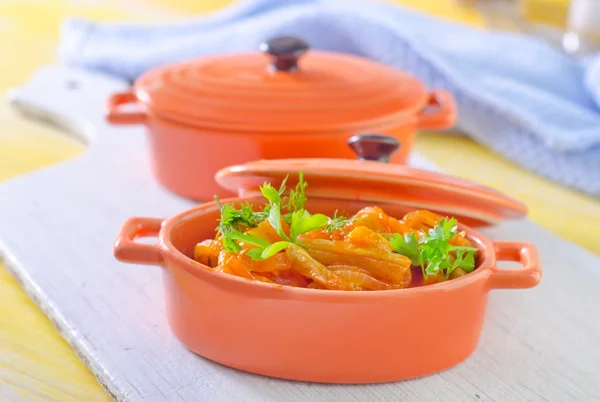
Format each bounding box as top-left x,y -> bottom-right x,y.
0,0 -> 600,401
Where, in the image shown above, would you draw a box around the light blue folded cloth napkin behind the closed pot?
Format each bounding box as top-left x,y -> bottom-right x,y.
59,0 -> 600,197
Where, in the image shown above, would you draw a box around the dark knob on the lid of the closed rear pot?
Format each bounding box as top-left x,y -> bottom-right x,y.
260,36 -> 309,72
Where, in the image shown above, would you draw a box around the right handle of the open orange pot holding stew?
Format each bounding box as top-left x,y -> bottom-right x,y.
489,241 -> 542,289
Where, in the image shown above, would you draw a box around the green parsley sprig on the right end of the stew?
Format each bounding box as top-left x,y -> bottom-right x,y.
389,218 -> 477,278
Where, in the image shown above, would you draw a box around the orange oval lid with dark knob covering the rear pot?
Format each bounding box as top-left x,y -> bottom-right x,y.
134,37 -> 427,132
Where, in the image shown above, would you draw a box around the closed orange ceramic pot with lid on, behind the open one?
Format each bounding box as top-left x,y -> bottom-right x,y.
107,38 -> 456,200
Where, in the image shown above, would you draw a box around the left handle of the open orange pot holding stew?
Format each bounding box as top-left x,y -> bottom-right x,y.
114,217 -> 164,265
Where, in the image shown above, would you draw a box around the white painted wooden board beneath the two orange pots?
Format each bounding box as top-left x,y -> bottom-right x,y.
0,68 -> 600,402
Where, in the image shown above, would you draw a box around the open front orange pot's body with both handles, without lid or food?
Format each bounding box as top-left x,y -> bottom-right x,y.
115,198 -> 541,383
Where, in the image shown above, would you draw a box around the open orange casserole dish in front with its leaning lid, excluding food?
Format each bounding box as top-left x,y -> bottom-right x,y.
114,137 -> 541,383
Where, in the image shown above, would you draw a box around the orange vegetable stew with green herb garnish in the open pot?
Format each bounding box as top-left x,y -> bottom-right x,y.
194,173 -> 478,291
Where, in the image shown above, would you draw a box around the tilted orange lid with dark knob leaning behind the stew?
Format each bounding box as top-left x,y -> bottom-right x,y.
216,135 -> 527,227
